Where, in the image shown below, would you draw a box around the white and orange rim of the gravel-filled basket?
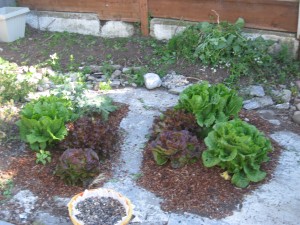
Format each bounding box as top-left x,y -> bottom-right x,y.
68,188 -> 133,225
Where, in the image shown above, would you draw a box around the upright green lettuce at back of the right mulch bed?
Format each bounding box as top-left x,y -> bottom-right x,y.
175,82 -> 243,128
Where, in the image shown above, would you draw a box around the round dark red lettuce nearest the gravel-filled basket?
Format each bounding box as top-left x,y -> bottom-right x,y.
55,148 -> 100,185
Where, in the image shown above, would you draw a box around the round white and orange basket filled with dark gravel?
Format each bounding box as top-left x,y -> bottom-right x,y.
68,188 -> 133,225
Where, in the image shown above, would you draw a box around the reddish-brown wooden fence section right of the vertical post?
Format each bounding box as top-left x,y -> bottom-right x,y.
148,0 -> 299,32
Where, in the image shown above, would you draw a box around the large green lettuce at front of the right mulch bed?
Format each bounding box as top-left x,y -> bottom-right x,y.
202,119 -> 272,188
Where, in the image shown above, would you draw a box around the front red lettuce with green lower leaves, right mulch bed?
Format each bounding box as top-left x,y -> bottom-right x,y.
150,130 -> 201,168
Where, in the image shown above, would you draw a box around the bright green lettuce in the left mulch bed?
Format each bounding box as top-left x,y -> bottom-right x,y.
16,95 -> 78,151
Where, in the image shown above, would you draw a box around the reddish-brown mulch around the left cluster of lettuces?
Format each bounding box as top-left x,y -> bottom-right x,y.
0,104 -> 128,216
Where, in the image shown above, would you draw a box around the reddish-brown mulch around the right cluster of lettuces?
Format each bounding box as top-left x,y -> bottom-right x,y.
138,111 -> 280,219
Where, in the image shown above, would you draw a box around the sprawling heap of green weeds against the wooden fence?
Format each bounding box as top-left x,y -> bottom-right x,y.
164,18 -> 300,84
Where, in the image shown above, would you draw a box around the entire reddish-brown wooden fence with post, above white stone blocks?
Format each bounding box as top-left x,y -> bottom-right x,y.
18,0 -> 299,35
